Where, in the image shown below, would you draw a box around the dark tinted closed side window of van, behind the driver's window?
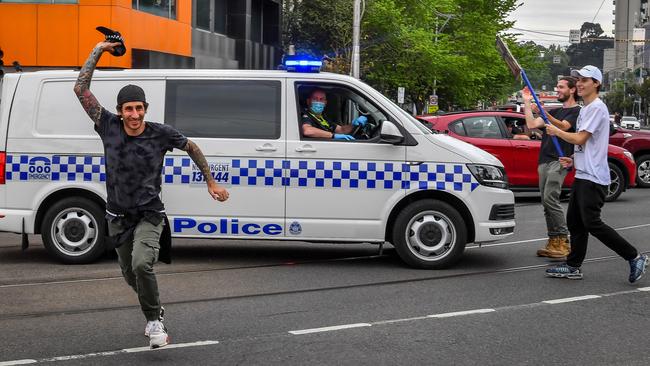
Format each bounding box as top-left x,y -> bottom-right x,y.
165,80 -> 281,139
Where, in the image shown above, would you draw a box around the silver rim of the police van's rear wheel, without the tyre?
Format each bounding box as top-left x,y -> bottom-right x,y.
50,207 -> 98,257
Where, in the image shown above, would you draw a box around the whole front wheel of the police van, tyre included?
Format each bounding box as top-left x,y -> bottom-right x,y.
392,199 -> 467,269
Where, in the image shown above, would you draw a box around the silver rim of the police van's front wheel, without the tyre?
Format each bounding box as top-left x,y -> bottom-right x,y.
405,211 -> 456,261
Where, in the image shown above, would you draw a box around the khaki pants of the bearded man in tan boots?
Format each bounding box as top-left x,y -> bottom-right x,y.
537,160 -> 569,237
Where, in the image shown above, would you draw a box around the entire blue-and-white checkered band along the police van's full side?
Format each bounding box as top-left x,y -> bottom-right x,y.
6,155 -> 479,192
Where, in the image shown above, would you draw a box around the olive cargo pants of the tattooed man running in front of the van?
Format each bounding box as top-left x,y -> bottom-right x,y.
108,220 -> 163,321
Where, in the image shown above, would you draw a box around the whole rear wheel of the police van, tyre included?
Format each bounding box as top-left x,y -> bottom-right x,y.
41,197 -> 106,264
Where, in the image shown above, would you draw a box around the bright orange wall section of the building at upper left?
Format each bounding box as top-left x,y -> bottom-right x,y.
0,0 -> 192,68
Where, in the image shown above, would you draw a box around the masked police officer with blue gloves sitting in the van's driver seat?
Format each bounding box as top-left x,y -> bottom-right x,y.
301,89 -> 368,141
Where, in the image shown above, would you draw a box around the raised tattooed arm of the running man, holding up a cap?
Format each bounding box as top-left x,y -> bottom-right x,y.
74,42 -> 119,125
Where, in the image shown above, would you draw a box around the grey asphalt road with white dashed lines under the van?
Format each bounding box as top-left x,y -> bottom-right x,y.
0,189 -> 650,366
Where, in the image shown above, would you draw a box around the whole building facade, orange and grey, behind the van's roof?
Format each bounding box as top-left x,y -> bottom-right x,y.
0,0 -> 282,71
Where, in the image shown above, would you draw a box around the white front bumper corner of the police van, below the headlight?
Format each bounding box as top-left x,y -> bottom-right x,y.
472,186 -> 515,243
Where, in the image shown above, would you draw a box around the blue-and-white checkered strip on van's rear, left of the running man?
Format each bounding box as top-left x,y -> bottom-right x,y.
5,155 -> 106,182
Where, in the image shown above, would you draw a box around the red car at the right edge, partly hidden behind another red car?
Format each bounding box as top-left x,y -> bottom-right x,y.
609,124 -> 650,187
